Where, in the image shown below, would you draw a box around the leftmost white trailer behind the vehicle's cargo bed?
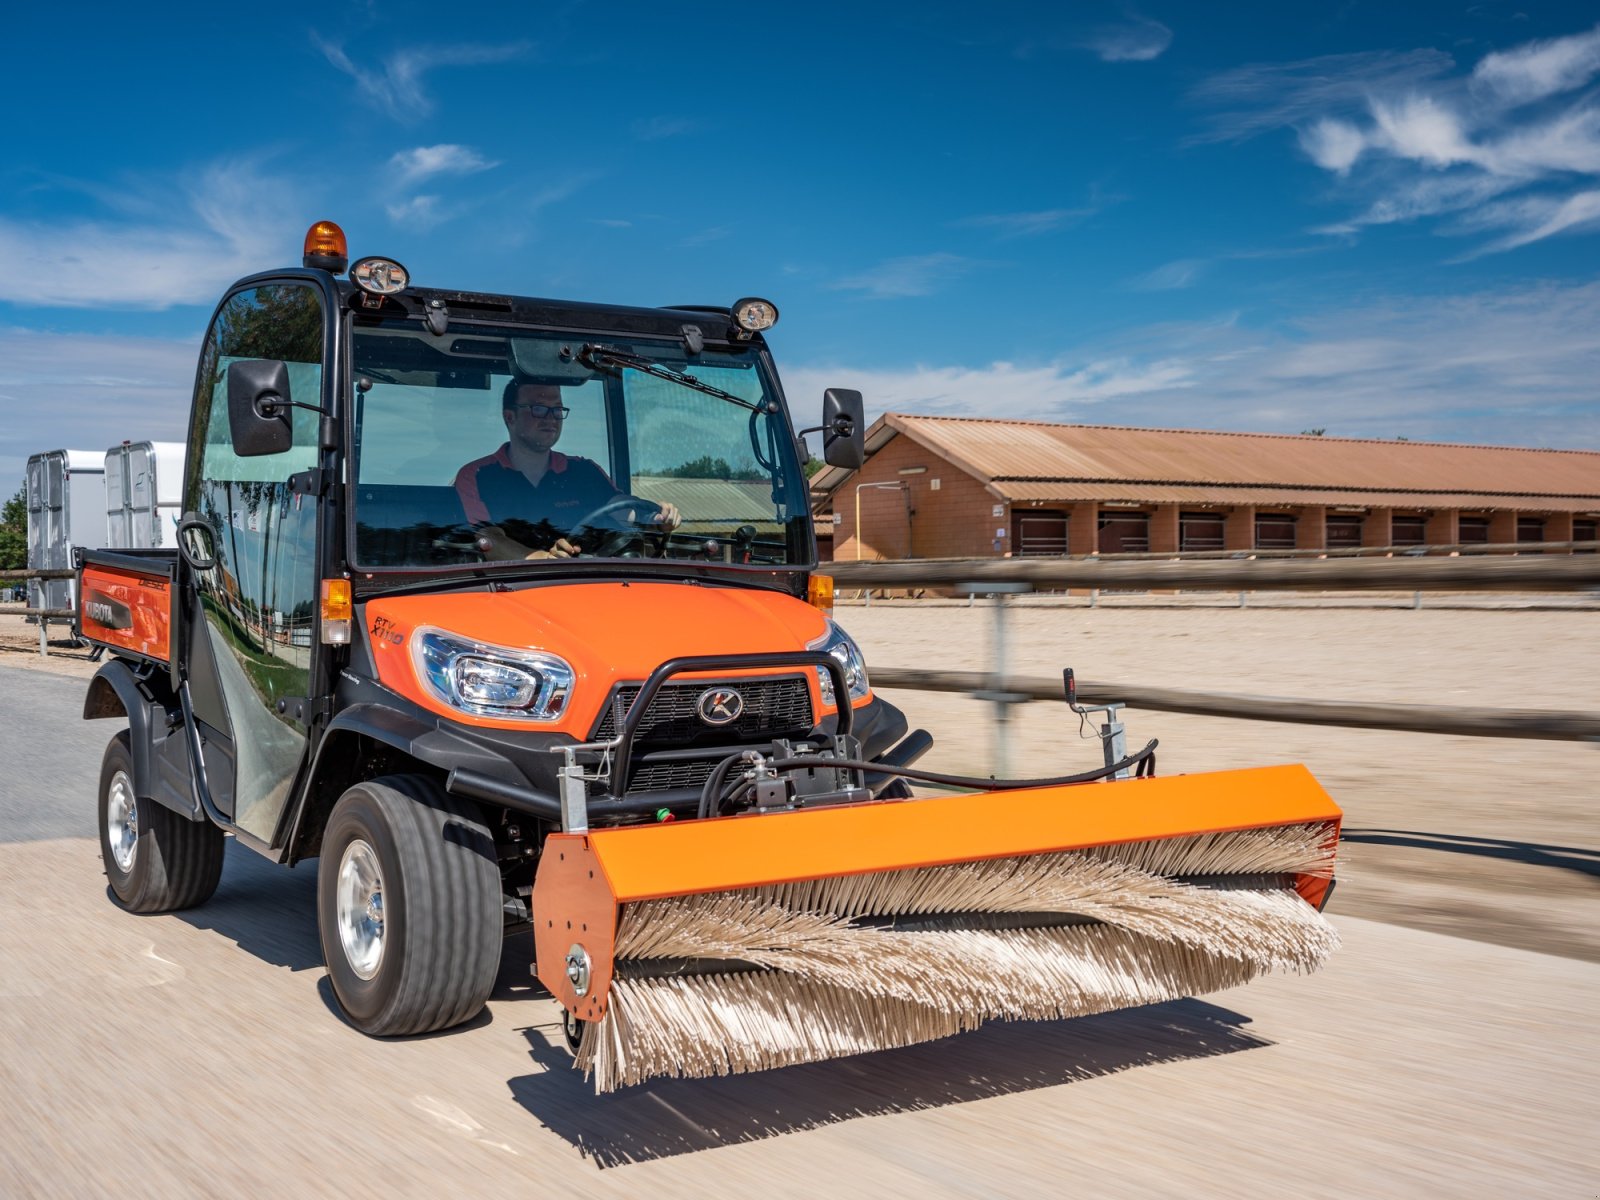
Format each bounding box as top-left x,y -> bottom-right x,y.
27,450 -> 106,621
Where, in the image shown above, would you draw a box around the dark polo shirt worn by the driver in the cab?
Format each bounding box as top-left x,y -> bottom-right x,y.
456,442 -> 619,546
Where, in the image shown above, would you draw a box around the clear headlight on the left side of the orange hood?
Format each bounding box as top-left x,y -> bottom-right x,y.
411,626 -> 573,722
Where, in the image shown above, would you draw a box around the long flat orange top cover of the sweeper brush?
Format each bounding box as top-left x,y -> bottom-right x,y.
546,763 -> 1342,904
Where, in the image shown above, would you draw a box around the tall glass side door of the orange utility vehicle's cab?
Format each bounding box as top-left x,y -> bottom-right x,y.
184,283 -> 325,842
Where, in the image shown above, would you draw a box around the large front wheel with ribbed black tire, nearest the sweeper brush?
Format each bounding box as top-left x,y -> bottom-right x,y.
317,774 -> 504,1037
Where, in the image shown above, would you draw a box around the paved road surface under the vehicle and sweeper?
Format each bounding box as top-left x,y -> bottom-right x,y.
0,669 -> 1600,1200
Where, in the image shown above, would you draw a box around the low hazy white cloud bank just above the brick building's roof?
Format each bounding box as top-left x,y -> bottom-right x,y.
784,283 -> 1600,450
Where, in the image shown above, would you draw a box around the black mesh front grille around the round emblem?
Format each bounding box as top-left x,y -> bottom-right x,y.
589,675 -> 814,748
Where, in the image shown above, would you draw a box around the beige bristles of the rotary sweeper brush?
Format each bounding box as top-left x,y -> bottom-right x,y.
578,824 -> 1339,1091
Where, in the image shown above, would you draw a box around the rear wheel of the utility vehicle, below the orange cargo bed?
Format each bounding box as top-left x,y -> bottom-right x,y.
99,730 -> 226,912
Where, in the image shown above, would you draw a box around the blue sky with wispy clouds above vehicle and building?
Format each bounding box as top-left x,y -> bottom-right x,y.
0,0 -> 1600,494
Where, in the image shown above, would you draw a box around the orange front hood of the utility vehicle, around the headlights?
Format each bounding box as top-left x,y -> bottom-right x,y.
365,582 -> 870,738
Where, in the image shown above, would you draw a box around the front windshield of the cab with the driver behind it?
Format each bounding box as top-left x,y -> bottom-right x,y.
354,322 -> 811,568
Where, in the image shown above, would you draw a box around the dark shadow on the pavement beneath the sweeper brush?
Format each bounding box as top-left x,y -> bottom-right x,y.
509,1000 -> 1272,1168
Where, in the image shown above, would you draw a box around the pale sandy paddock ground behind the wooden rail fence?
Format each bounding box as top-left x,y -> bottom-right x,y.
0,597 -> 1600,962
